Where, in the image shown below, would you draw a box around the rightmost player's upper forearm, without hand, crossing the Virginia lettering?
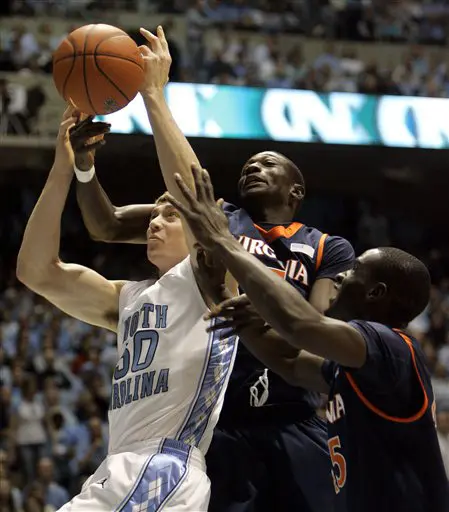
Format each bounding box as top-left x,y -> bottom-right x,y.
217,236 -> 324,349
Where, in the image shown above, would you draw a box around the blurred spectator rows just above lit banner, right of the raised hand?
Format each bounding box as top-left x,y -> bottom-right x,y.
194,37 -> 449,97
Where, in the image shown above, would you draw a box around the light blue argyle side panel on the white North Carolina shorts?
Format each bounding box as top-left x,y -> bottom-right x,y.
117,439 -> 191,512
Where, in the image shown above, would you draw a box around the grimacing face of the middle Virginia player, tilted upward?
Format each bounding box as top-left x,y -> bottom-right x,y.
238,151 -> 294,202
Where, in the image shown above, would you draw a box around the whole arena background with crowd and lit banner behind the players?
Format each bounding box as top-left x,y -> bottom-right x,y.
0,0 -> 449,512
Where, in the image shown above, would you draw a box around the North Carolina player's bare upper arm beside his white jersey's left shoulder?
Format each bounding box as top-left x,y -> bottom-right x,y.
35,262 -> 125,331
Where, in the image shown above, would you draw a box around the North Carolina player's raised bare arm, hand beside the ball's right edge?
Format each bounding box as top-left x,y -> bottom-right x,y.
140,26 -> 199,255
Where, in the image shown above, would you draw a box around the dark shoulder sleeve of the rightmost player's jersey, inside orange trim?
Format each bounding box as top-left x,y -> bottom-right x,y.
345,320 -> 424,417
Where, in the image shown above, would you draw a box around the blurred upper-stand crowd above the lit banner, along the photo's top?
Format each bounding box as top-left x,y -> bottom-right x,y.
0,0 -> 449,110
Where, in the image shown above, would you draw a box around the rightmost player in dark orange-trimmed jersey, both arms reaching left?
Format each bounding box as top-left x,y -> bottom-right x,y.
163,169 -> 449,512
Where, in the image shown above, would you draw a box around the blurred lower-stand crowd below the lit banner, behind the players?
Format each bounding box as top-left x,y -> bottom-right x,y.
0,180 -> 449,512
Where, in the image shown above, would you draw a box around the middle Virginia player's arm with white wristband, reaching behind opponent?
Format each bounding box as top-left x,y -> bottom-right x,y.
70,117 -> 153,244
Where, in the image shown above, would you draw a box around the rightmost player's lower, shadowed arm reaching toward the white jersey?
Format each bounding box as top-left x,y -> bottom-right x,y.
209,294 -> 329,393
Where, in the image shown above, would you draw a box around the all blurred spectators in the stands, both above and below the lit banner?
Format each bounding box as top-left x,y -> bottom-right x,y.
0,0 -> 449,512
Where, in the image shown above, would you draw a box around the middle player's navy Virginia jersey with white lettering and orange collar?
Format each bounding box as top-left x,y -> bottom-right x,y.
220,203 -> 354,425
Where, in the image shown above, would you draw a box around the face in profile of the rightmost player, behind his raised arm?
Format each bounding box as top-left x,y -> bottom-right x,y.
327,249 -> 381,321
